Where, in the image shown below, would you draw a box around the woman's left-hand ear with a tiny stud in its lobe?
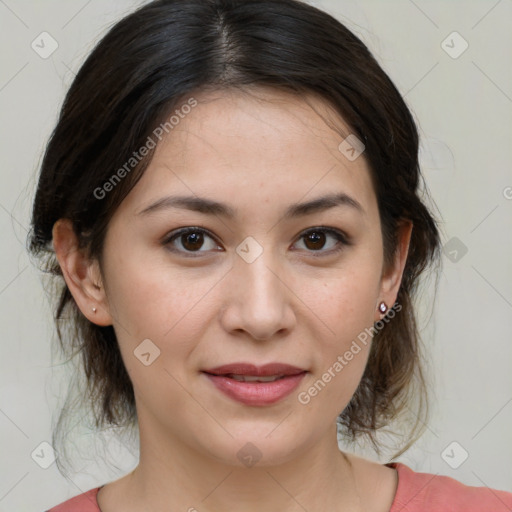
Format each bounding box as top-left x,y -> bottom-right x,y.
52,219 -> 112,326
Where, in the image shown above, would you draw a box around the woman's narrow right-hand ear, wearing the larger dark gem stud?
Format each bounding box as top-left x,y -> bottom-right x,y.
375,220 -> 413,321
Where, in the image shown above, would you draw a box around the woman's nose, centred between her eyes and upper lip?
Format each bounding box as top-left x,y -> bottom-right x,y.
221,247 -> 296,340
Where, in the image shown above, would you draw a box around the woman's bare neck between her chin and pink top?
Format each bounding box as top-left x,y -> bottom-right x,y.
119,418 -> 362,512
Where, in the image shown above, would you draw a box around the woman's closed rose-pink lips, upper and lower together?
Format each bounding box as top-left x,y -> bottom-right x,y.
203,363 -> 307,406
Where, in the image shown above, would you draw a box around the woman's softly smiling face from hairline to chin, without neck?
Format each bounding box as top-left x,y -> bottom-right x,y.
76,89 -> 410,465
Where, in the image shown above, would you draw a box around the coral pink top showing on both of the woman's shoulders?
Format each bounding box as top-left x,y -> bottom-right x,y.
46,462 -> 512,512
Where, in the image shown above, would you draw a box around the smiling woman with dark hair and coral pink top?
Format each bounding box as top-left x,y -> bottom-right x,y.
31,0 -> 512,512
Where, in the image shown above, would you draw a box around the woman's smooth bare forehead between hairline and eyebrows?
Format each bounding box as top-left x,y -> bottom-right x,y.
118,88 -> 375,222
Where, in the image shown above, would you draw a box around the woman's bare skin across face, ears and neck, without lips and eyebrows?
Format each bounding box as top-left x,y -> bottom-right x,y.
53,89 -> 412,512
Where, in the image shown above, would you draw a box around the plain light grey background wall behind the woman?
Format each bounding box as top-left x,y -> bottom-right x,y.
0,0 -> 512,512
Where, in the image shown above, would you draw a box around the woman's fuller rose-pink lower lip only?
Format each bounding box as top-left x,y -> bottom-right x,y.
205,372 -> 306,406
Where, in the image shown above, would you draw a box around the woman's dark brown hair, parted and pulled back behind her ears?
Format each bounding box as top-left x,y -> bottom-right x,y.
29,0 -> 440,474
